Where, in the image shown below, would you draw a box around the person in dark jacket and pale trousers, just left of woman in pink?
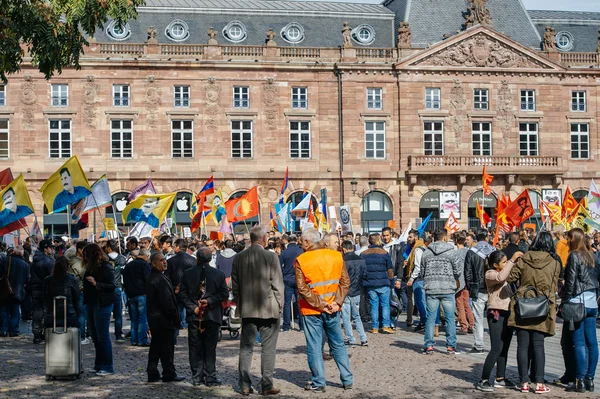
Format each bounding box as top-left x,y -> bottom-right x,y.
465,229 -> 496,355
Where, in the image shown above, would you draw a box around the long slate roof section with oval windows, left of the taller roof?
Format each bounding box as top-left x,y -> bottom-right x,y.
95,0 -> 395,48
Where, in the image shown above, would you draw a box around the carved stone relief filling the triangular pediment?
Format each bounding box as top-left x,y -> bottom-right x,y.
415,33 -> 550,69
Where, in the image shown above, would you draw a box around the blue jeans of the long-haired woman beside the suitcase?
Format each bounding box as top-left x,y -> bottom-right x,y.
87,304 -> 115,373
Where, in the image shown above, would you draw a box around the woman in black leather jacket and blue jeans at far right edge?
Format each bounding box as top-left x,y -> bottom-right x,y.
562,228 -> 600,392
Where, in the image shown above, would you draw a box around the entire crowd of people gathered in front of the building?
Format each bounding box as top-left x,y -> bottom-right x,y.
0,226 -> 600,395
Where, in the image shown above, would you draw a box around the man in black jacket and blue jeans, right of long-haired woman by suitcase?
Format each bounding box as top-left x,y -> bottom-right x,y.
122,249 -> 150,346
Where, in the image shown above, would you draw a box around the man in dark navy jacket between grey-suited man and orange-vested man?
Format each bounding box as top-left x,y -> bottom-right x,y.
279,235 -> 304,332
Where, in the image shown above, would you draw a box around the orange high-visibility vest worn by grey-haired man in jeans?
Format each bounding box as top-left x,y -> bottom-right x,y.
296,248 -> 344,316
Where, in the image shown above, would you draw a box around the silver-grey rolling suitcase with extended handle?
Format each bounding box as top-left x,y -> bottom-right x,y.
44,296 -> 82,380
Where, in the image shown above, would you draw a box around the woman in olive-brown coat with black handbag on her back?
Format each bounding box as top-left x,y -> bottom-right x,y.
507,231 -> 561,393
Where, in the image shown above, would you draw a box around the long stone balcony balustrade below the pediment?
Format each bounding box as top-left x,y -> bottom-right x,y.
408,155 -> 565,175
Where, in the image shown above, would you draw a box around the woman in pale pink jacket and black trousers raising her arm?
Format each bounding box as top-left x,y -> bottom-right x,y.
475,251 -> 523,392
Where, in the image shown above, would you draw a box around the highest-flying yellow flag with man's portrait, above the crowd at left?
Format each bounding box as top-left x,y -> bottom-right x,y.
40,155 -> 92,213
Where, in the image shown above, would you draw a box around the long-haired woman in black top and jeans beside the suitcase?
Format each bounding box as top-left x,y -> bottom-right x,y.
83,244 -> 116,376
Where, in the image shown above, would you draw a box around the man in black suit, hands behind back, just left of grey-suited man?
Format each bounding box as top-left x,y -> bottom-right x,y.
179,247 -> 229,387
